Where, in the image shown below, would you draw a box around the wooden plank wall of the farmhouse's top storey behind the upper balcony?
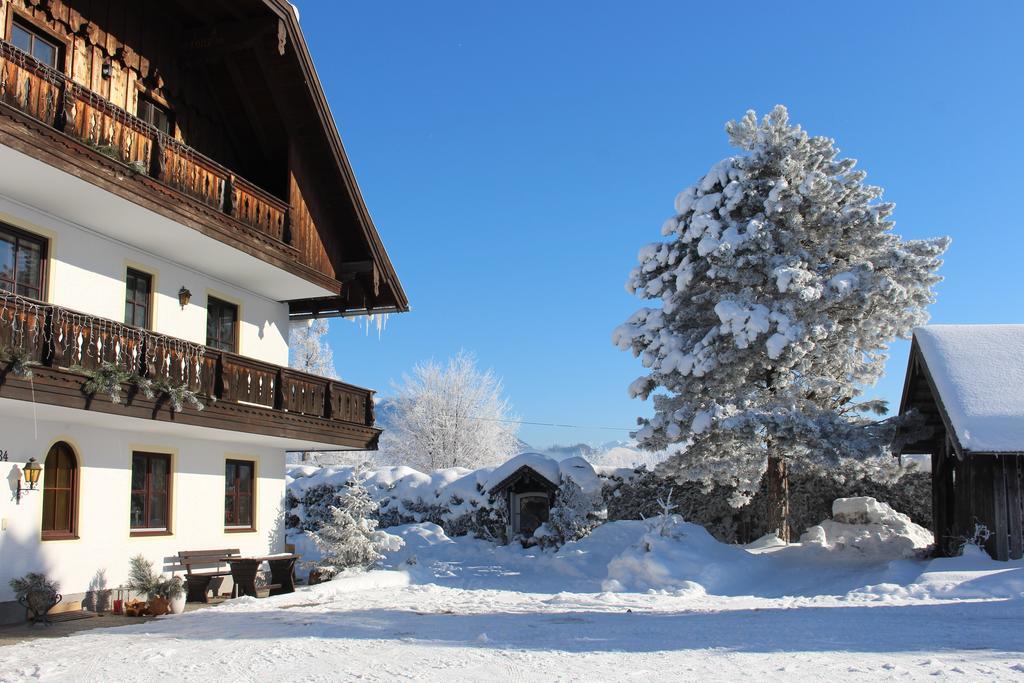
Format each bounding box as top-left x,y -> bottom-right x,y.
0,0 -> 238,174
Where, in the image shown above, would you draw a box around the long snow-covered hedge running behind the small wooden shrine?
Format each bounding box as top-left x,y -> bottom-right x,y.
288,454 -> 932,547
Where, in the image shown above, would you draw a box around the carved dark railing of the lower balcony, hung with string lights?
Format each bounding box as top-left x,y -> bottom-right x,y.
0,292 -> 374,427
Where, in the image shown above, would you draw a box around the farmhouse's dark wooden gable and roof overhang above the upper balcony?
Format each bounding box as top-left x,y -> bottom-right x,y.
0,0 -> 409,317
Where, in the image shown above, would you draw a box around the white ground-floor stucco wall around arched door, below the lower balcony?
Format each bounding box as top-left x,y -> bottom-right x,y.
0,415 -> 285,603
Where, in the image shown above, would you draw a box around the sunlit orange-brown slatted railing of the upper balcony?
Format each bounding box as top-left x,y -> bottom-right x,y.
0,41 -> 288,242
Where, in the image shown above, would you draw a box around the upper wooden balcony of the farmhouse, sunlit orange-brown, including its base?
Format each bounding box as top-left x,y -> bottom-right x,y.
0,41 -> 340,291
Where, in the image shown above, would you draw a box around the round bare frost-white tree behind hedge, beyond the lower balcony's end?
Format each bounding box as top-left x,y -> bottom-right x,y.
381,351 -> 518,472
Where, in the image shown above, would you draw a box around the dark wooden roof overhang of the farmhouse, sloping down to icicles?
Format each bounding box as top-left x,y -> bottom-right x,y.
165,0 -> 410,319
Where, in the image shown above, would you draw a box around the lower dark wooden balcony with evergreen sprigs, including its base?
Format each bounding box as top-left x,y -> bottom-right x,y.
0,292 -> 380,450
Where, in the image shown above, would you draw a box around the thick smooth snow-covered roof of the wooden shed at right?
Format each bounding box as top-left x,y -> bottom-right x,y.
913,325 -> 1024,453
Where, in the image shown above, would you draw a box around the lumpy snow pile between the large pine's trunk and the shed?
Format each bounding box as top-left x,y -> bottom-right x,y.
800,497 -> 933,560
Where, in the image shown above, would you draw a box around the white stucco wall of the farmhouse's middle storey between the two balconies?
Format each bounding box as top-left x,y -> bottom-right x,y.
0,196 -> 288,366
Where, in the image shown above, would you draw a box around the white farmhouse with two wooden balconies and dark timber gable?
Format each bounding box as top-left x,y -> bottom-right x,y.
0,0 -> 409,623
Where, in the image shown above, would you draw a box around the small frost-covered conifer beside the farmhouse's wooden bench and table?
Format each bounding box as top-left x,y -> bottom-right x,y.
307,474 -> 403,577
